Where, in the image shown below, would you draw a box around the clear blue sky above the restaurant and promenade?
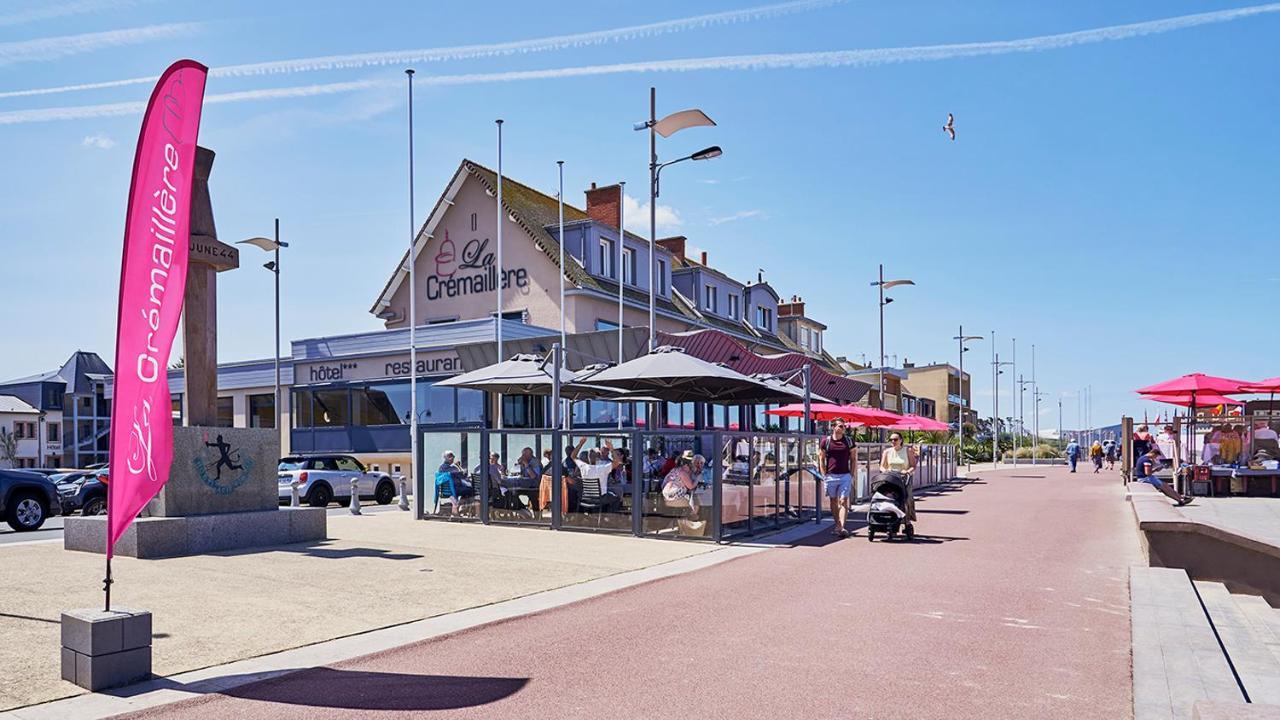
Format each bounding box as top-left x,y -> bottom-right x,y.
0,0 -> 1280,428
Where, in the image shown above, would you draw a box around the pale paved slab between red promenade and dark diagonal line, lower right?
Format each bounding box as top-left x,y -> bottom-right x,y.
1129,566 -> 1244,720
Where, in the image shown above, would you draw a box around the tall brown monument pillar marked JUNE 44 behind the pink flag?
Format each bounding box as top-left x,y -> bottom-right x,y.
182,147 -> 239,427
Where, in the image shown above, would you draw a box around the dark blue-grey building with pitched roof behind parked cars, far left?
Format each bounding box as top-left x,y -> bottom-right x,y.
0,351 -> 111,468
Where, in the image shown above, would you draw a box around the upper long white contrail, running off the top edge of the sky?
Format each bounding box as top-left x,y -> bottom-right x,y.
0,0 -> 845,99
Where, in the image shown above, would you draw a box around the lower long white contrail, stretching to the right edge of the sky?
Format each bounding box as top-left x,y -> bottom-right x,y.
0,3 -> 1280,124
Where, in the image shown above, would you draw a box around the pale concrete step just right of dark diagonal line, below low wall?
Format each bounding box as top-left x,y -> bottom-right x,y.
1196,580 -> 1280,705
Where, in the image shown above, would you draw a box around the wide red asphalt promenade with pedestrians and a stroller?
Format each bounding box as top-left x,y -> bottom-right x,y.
122,458 -> 1140,720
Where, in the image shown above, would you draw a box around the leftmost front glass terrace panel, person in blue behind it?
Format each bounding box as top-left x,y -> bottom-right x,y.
419,430 -> 481,520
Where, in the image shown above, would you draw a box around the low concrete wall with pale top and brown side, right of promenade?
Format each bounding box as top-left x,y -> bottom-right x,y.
1129,483 -> 1280,606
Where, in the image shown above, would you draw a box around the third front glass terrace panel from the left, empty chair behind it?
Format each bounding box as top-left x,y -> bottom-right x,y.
563,433 -> 634,532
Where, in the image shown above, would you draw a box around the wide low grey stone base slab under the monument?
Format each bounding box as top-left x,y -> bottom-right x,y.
63,507 -> 326,559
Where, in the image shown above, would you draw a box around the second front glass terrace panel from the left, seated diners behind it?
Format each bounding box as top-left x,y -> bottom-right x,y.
489,432 -> 550,525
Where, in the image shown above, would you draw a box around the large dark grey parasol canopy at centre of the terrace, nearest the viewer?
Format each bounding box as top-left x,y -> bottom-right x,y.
584,346 -> 796,404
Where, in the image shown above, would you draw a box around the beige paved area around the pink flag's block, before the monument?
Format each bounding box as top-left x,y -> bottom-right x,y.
0,512 -> 717,711
